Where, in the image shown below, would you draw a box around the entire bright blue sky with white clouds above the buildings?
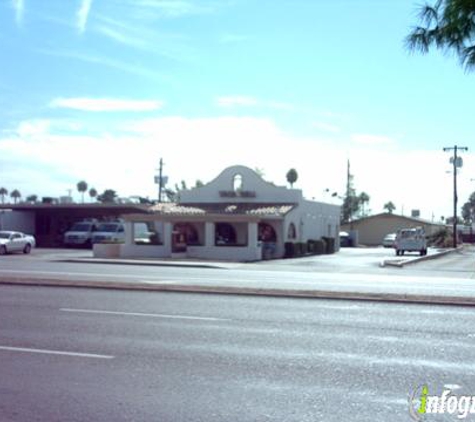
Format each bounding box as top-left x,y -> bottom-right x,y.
0,0 -> 475,219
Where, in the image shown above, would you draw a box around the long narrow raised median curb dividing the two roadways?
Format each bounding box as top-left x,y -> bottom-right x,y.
0,277 -> 475,306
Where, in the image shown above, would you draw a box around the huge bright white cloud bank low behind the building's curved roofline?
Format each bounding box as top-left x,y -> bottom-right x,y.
0,116 -> 468,220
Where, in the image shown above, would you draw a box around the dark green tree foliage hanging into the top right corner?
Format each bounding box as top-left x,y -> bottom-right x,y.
406,0 -> 475,69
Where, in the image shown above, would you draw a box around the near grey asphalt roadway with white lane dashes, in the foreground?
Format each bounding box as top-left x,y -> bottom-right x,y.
0,285 -> 475,422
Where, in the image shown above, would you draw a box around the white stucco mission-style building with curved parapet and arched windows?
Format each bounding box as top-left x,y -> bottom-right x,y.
113,166 -> 340,261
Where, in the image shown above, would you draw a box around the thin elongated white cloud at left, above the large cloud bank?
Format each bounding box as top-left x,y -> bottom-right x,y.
50,98 -> 163,112
